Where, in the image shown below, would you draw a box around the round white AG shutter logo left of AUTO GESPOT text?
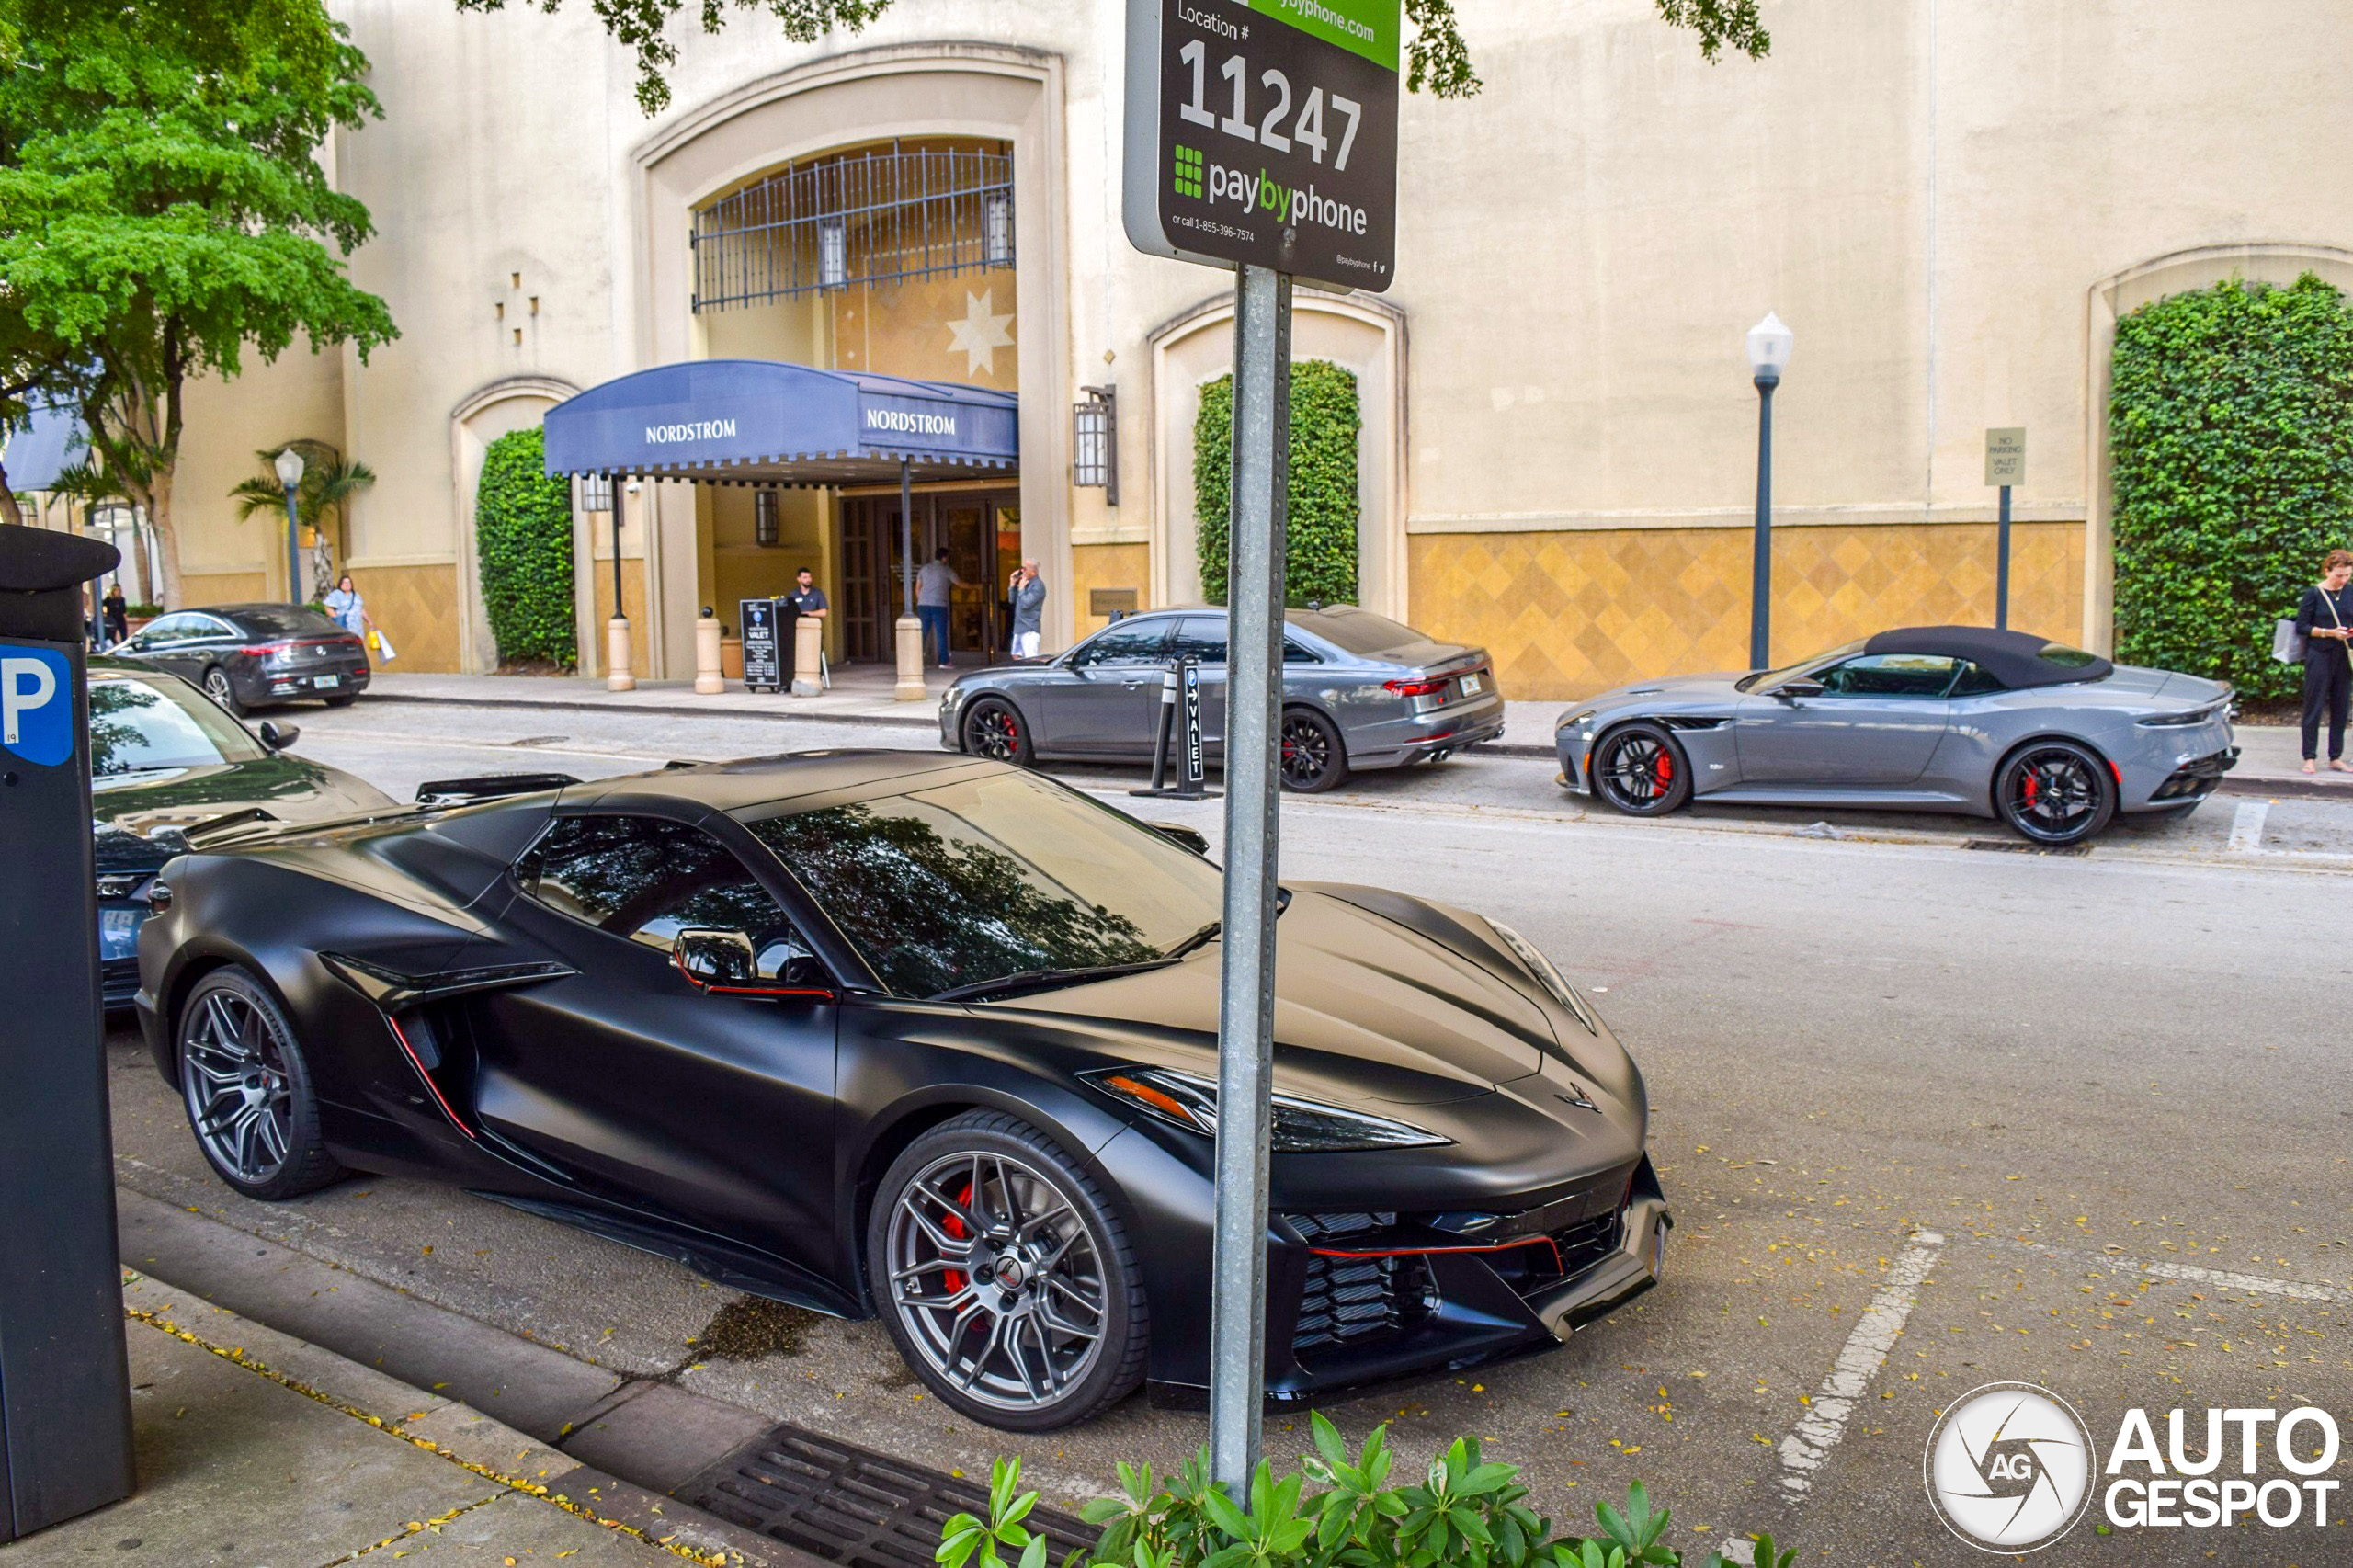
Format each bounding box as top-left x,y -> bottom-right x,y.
1923,1382 -> 2092,1556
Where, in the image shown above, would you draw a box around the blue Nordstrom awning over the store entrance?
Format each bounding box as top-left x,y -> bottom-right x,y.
543,360 -> 1021,485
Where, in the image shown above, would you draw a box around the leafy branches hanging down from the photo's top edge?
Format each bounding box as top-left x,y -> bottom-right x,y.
457,0 -> 1772,116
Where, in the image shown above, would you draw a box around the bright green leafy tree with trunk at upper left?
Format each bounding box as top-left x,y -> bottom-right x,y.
0,0 -> 395,603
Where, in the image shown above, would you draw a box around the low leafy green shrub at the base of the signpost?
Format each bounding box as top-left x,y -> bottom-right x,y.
934,1413 -> 1798,1568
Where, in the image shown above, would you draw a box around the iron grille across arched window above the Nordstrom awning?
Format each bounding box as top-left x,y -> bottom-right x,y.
688,142 -> 1014,311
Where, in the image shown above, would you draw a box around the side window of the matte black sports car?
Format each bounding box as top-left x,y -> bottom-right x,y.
516,814 -> 821,980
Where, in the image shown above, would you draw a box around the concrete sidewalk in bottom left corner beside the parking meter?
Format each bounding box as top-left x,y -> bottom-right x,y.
0,1269 -> 807,1568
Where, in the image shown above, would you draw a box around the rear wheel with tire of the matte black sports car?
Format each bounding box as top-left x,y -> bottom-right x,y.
172,968 -> 344,1203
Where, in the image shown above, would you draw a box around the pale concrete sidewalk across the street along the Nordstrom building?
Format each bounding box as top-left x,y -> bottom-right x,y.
365,666 -> 2353,801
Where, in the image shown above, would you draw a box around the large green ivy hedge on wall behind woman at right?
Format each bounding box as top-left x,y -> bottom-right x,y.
2109,273 -> 2353,697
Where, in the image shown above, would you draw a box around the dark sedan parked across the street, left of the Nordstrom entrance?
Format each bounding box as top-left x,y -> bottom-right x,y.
113,605 -> 367,713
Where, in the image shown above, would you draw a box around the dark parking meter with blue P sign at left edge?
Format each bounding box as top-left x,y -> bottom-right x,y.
0,525 -> 131,1542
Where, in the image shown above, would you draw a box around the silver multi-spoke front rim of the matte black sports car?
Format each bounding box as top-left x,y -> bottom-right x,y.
885,1152 -> 1106,1410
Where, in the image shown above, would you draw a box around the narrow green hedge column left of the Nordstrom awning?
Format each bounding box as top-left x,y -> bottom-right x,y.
473,424 -> 579,668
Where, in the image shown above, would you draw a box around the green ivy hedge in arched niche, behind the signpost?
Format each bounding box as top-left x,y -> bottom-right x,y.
1193,360 -> 1365,605
